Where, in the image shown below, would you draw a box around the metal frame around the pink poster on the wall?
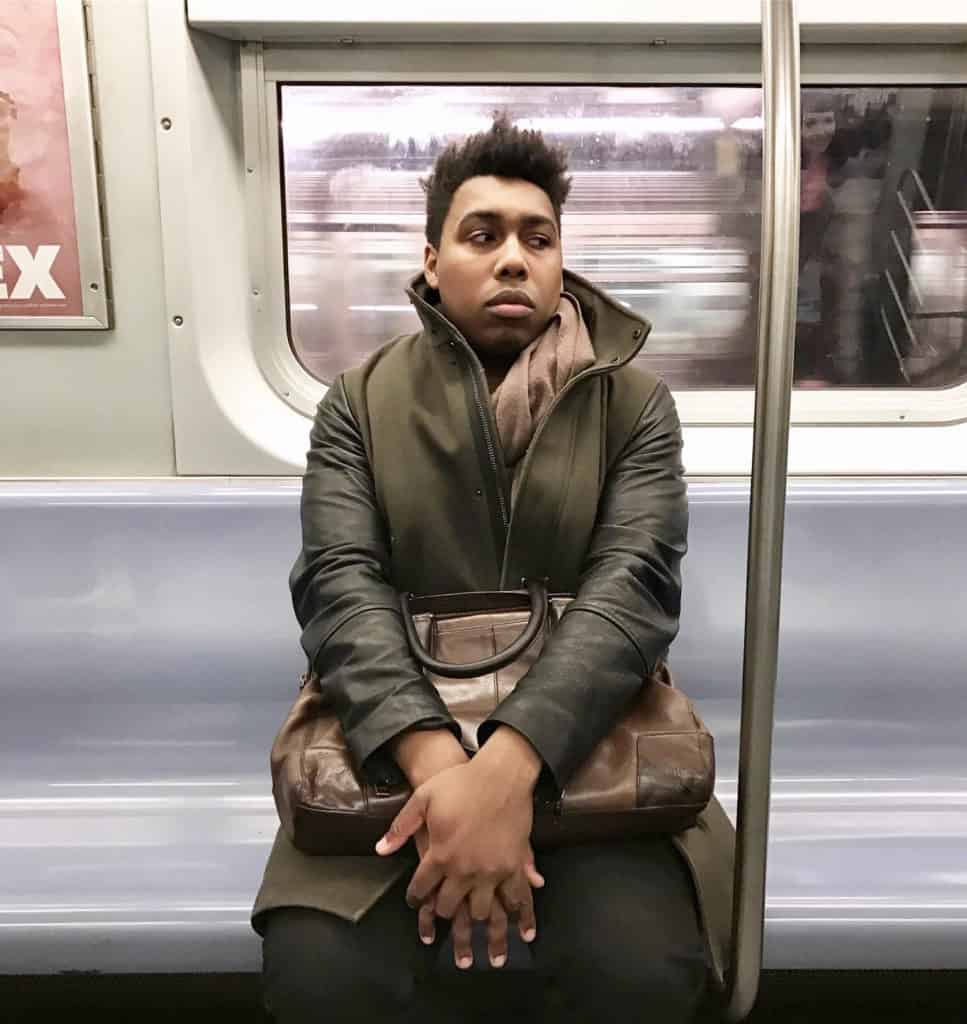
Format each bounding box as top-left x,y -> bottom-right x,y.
0,0 -> 111,331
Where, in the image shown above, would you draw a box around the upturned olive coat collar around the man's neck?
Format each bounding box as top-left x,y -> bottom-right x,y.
407,270 -> 651,368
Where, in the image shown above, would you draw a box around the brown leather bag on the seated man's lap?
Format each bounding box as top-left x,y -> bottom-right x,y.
271,583 -> 715,854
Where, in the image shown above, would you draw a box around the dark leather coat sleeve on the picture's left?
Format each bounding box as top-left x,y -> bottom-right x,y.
289,378 -> 460,781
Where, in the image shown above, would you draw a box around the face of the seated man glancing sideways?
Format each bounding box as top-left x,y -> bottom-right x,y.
424,176 -> 561,356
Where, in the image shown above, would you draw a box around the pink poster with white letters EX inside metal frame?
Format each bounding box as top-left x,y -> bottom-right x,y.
0,0 -> 83,315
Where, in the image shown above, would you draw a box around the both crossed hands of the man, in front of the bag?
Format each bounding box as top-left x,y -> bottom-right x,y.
376,726 -> 544,968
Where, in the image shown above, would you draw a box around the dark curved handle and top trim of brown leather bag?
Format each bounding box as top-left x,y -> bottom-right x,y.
400,580 -> 548,679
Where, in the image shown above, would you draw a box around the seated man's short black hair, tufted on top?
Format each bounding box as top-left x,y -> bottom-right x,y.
420,114 -> 571,248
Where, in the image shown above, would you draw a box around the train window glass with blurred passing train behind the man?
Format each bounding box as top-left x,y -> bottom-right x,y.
281,85 -> 967,389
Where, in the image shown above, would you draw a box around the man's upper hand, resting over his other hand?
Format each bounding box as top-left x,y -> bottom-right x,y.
376,726 -> 543,930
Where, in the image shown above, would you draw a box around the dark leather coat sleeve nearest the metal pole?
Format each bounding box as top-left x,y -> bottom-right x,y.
477,383 -> 688,788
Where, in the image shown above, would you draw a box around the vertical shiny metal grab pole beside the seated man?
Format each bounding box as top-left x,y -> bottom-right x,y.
725,0 -> 800,1024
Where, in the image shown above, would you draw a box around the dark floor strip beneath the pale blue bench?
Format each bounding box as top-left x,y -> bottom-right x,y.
0,971 -> 967,1024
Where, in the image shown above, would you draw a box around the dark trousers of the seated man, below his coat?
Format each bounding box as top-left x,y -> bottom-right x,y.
262,838 -> 706,1024
